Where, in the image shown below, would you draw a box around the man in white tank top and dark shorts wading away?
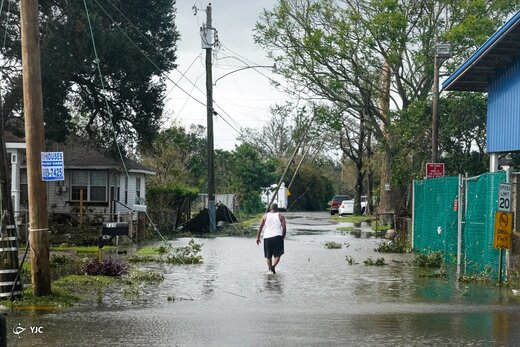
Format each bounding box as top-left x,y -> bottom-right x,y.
256,204 -> 287,274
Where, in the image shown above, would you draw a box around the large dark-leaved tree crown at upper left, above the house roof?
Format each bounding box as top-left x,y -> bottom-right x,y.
1,0 -> 179,152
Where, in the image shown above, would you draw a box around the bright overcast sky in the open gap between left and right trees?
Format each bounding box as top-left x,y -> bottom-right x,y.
166,0 -> 286,150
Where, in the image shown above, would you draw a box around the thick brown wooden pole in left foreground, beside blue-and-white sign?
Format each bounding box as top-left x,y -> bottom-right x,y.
20,0 -> 51,296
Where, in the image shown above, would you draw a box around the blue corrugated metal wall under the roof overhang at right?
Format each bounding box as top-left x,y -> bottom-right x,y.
487,60 -> 520,153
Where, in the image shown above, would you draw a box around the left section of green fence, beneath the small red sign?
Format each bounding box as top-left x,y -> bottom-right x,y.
413,177 -> 459,262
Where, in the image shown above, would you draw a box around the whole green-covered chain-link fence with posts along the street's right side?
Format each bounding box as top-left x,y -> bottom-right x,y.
412,171 -> 507,275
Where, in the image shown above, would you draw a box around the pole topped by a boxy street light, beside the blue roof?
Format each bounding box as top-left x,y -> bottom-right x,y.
431,43 -> 451,163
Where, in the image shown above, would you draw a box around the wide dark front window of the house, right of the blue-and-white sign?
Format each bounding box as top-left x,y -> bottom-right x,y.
70,170 -> 107,202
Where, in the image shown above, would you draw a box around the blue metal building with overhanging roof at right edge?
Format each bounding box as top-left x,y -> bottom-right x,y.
442,11 -> 520,172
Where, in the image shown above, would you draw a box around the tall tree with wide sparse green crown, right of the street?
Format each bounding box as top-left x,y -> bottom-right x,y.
255,0 -> 517,215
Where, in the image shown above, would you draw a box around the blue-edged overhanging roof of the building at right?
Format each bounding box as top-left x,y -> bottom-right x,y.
442,11 -> 520,92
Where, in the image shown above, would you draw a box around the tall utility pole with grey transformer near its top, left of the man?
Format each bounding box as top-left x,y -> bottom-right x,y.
201,3 -> 217,232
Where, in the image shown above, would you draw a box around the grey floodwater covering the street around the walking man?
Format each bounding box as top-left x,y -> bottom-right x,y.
7,212 -> 520,346
